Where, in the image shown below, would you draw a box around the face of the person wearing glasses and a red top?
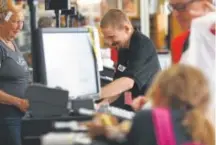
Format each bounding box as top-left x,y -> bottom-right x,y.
169,0 -> 205,29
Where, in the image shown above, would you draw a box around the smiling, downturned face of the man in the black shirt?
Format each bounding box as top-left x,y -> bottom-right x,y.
101,26 -> 130,49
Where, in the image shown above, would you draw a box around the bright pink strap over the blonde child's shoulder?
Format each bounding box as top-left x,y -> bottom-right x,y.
152,108 -> 176,145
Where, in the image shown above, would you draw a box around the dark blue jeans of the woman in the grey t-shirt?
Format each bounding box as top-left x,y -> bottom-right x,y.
0,118 -> 21,145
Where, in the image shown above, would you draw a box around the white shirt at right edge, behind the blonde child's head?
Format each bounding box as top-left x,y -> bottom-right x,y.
180,12 -> 216,123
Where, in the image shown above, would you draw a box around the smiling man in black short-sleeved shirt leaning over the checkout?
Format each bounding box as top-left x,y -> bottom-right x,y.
100,9 -> 160,110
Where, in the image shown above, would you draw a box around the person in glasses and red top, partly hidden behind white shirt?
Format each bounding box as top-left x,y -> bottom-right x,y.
169,0 -> 215,63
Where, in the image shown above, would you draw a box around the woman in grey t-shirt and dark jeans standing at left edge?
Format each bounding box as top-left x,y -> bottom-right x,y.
0,0 -> 29,145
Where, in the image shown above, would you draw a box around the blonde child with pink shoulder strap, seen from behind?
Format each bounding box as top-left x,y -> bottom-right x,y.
89,64 -> 215,145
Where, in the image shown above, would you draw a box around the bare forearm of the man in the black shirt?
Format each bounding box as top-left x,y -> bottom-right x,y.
101,77 -> 134,101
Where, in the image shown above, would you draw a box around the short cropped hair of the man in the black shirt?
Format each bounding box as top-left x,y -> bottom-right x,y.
100,9 -> 132,28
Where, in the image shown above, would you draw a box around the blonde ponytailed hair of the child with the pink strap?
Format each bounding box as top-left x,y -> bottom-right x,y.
147,65 -> 215,145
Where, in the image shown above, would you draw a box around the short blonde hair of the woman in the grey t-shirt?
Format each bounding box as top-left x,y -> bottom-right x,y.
0,0 -> 23,23
